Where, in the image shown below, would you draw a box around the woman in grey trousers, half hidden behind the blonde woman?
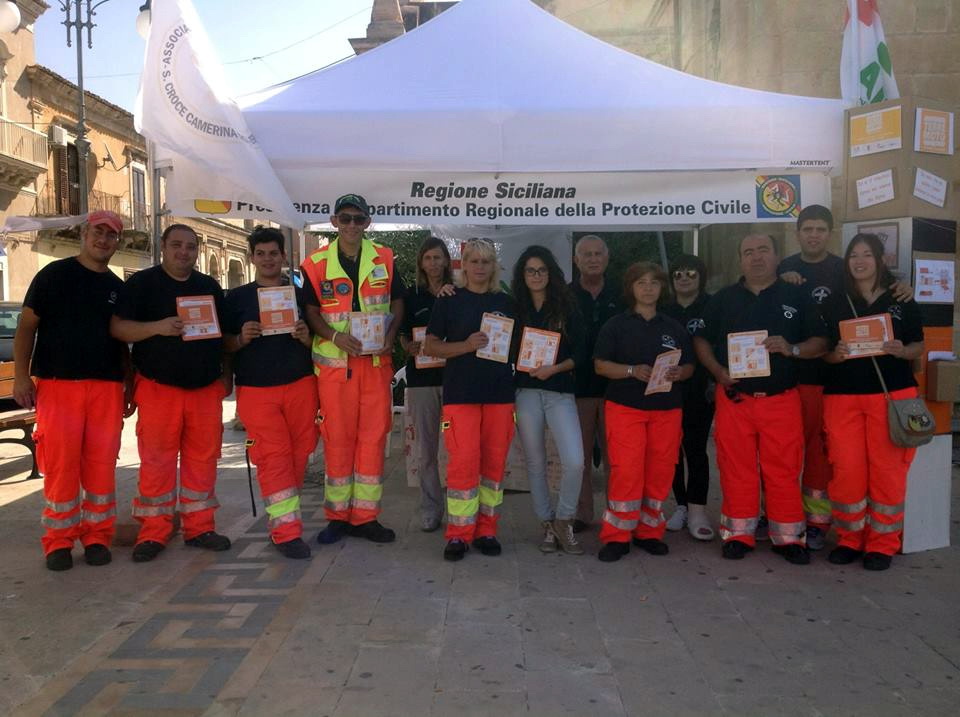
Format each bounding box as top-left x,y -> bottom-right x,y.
400,237 -> 453,533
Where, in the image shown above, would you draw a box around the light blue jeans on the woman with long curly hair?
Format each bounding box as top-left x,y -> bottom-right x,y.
516,388 -> 583,520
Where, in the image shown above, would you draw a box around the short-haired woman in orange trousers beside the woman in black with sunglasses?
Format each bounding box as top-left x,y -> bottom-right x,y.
594,262 -> 693,562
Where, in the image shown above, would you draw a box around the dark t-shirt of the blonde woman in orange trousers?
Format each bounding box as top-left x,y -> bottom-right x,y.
427,289 -> 517,404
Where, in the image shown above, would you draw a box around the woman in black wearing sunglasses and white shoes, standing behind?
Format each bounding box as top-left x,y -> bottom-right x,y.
663,254 -> 714,540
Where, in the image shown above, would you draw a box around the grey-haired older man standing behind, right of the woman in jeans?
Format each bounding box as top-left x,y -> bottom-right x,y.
570,234 -> 621,533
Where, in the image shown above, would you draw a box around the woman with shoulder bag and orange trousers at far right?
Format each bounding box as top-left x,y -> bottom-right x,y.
823,234 -> 923,570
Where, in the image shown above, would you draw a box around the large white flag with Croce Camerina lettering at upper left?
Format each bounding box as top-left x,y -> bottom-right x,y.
134,0 -> 294,227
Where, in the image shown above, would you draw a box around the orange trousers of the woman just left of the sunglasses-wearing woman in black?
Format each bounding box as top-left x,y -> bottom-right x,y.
600,401 -> 683,543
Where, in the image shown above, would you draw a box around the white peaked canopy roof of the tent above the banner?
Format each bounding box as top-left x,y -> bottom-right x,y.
240,0 -> 843,178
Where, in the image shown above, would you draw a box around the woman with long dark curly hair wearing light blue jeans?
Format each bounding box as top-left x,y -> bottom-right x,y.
511,245 -> 584,555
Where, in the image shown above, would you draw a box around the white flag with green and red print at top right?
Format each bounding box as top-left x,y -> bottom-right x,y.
840,0 -> 900,107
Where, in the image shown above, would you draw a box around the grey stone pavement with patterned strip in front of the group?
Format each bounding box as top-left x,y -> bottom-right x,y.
0,394 -> 960,717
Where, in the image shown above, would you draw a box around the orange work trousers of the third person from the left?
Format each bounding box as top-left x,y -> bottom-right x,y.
237,376 -> 318,543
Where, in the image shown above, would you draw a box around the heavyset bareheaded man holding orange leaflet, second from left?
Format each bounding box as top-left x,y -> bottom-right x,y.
110,224 -> 230,562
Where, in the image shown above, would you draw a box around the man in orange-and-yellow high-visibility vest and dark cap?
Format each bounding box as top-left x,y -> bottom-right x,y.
301,194 -> 404,544
